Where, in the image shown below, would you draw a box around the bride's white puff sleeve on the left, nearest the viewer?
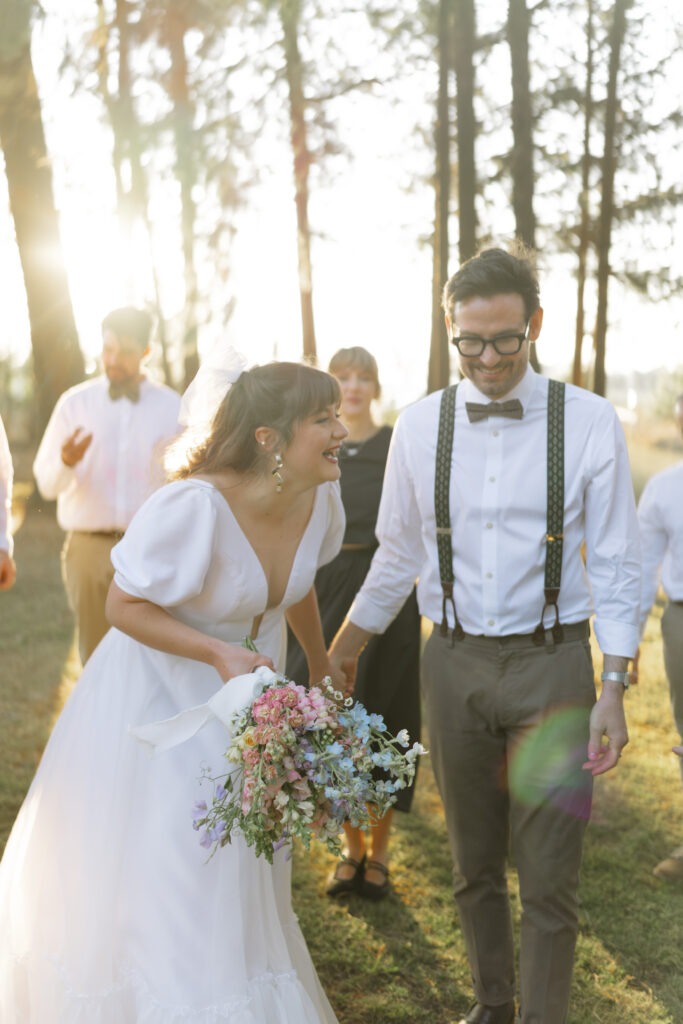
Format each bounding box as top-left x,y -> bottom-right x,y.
112,481 -> 216,608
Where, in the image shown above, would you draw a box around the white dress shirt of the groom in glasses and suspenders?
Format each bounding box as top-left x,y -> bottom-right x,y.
349,367 -> 640,656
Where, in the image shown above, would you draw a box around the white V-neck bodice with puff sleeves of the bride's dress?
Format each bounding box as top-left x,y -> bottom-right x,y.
112,478 -> 344,668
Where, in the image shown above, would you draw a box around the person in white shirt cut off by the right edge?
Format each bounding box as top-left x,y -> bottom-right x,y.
635,394 -> 683,882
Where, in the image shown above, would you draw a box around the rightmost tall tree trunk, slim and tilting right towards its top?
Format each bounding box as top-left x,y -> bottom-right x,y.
593,0 -> 632,395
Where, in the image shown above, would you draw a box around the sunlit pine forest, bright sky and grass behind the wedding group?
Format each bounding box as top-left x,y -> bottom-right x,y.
0,0 -> 683,1024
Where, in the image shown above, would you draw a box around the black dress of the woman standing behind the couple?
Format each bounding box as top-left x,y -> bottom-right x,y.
287,426 -> 421,811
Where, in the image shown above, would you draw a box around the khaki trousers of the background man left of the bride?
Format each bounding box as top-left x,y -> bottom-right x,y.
61,530 -> 123,665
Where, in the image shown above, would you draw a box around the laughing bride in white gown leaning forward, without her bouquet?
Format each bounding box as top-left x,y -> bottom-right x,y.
0,362 -> 346,1024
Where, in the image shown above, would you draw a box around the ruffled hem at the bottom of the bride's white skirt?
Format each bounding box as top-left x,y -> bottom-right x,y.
0,962 -> 336,1024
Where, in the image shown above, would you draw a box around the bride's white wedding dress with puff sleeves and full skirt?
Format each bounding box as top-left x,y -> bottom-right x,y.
0,480 -> 343,1024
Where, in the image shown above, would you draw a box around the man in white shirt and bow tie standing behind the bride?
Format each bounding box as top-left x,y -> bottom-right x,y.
33,306 -> 180,664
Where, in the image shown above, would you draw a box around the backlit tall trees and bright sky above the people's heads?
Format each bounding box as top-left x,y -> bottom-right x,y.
0,0 -> 683,441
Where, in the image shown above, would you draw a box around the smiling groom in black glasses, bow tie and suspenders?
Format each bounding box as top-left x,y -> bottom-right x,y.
331,246 -> 640,1024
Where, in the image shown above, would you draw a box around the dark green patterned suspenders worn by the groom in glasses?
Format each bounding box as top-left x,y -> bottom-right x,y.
434,380 -> 564,647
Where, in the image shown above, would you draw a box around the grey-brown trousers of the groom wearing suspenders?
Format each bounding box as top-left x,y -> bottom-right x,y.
422,624 -> 595,1024
